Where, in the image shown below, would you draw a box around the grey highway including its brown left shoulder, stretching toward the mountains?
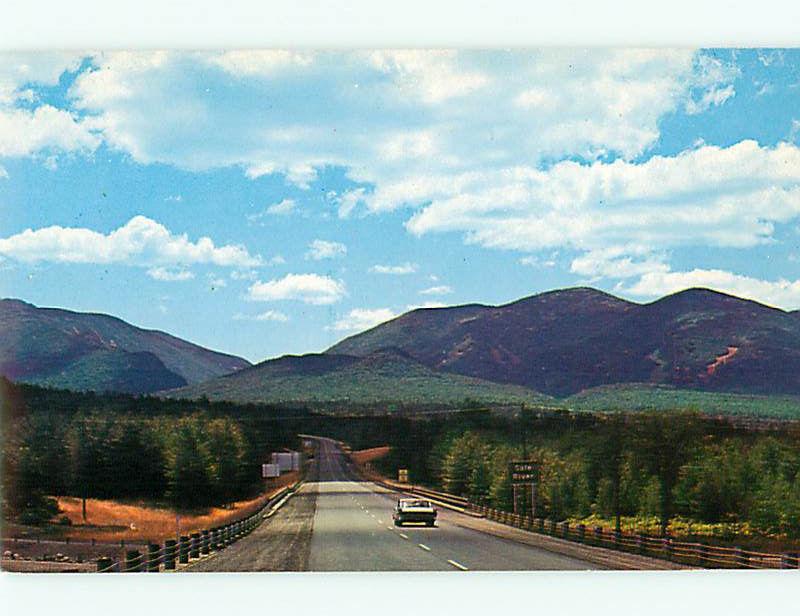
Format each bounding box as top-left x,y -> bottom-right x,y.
189,438 -> 602,571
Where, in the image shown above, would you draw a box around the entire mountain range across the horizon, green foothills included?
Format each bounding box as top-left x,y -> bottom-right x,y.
0,287 -> 800,404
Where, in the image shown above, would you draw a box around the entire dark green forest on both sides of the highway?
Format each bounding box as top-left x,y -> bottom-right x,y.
0,382 -> 800,541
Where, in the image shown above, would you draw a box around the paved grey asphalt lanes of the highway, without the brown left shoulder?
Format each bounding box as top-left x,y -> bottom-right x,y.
308,439 -> 598,571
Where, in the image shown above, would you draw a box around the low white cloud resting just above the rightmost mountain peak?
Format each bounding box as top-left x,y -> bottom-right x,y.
625,269 -> 800,309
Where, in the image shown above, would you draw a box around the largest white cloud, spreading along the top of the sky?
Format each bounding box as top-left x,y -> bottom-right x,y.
64,49 -> 735,207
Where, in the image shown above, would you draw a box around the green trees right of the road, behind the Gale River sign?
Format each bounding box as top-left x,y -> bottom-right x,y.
372,412 -> 800,538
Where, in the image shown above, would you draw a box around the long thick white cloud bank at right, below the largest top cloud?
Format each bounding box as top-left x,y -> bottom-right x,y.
407,141 -> 800,268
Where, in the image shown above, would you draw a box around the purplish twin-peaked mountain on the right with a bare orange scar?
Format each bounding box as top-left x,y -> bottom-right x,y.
327,288 -> 800,397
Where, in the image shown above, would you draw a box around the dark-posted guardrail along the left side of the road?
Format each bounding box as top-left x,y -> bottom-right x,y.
1,481 -> 302,573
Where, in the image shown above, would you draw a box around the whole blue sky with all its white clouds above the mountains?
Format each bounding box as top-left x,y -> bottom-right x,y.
0,48 -> 800,361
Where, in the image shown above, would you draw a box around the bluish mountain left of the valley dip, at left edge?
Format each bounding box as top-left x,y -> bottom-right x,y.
0,299 -> 250,393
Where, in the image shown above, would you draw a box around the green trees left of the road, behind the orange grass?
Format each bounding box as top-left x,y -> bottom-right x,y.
3,411 -> 259,523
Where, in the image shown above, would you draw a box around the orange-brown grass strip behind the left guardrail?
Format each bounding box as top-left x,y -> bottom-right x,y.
42,473 -> 297,542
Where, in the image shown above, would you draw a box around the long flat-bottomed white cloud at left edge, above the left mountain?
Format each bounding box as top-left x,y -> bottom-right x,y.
0,216 -> 261,267
